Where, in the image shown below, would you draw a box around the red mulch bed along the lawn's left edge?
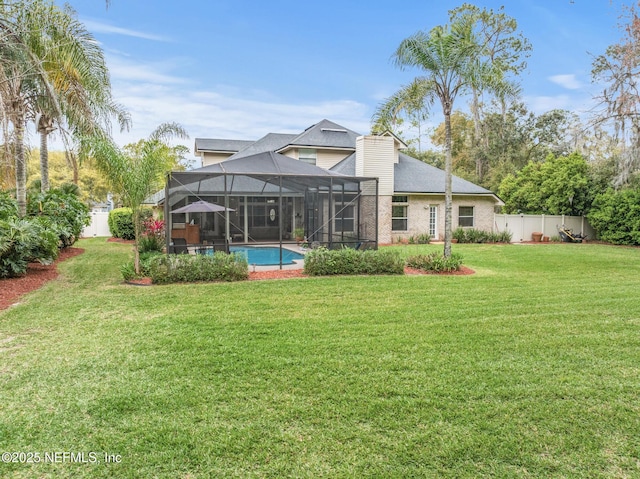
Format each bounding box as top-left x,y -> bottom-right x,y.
0,248 -> 84,310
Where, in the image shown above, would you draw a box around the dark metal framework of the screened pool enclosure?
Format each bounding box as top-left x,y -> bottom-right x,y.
164,171 -> 379,268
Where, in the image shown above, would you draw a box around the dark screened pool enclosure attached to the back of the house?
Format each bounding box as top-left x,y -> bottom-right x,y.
164,152 -> 378,266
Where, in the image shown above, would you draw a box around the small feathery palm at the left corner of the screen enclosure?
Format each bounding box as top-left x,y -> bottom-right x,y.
83,123 -> 188,274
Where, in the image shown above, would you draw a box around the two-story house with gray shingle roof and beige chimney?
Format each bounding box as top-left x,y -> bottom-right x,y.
189,120 -> 502,244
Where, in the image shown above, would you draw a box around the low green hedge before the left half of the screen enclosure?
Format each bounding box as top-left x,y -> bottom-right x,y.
148,251 -> 249,284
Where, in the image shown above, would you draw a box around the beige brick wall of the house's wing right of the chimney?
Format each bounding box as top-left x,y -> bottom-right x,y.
390,195 -> 495,243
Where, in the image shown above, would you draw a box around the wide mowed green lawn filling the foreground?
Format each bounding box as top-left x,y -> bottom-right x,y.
0,239 -> 640,478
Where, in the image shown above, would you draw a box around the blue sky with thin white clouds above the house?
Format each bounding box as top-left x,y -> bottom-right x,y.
57,0 -> 631,163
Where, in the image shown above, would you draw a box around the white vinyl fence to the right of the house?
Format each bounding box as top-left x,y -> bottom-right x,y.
493,215 -> 596,243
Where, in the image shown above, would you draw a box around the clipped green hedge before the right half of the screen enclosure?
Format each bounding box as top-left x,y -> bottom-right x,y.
304,247 -> 404,276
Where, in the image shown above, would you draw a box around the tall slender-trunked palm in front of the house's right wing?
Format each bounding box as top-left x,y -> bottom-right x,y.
394,17 -> 503,257
